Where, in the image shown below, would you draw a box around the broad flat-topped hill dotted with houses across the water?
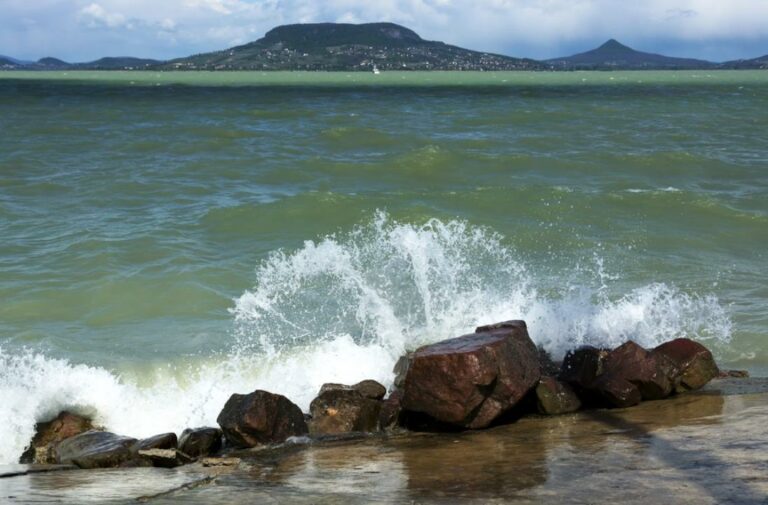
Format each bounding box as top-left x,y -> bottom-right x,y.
162,23 -> 543,71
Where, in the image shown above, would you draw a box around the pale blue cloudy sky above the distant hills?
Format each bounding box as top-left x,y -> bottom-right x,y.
0,0 -> 768,62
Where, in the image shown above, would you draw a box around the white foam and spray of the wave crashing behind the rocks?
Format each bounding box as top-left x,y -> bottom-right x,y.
0,213 -> 731,464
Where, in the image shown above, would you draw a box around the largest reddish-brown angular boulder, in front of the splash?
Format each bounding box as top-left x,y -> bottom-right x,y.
402,321 -> 540,429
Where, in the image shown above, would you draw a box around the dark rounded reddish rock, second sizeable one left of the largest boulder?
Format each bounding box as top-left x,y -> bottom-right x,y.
216,390 -> 308,447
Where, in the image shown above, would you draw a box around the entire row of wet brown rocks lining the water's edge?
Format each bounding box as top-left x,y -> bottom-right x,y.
13,321 -> 732,470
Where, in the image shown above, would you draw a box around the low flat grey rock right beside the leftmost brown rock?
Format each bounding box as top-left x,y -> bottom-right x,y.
56,431 -> 141,468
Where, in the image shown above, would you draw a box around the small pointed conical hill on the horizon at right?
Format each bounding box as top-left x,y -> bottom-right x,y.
546,39 -> 717,70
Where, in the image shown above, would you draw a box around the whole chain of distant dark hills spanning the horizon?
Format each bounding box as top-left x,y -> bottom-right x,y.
0,23 -> 768,71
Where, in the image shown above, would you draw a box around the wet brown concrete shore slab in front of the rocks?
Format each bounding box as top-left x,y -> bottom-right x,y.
0,379 -> 768,504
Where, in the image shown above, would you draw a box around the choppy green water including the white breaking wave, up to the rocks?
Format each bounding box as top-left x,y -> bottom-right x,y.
0,71 -> 768,461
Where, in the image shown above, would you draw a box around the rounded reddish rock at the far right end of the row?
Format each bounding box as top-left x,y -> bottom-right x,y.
652,338 -> 720,393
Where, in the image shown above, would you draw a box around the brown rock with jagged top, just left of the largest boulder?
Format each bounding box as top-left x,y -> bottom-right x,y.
309,381 -> 386,435
